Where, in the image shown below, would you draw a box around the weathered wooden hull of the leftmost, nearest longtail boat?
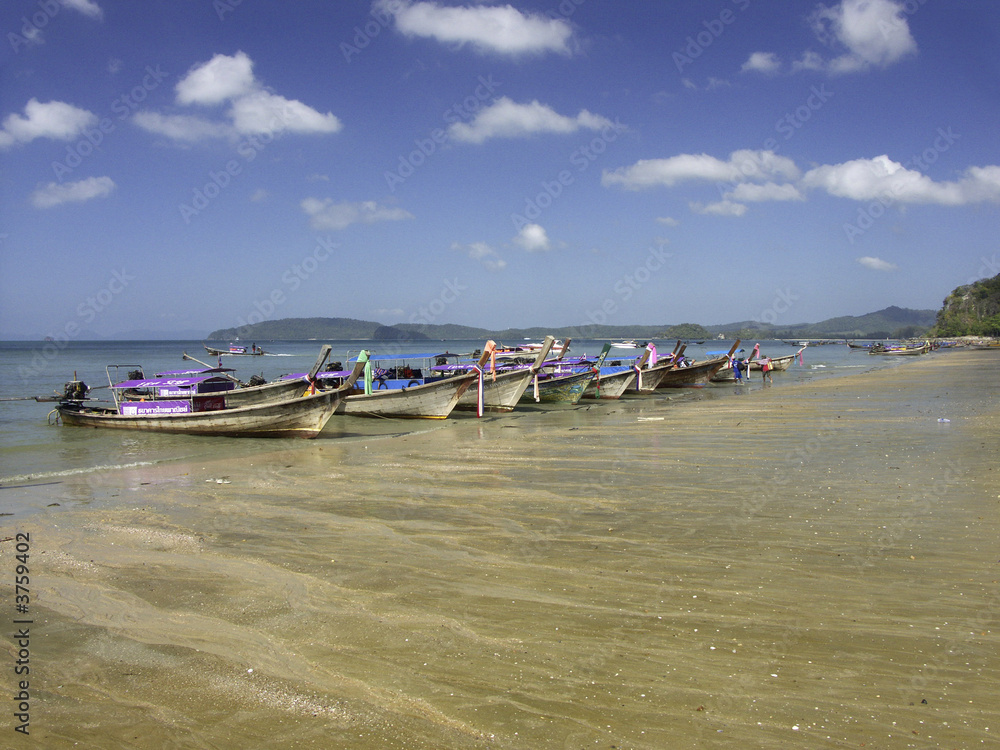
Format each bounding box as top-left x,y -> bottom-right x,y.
57,391 -> 341,438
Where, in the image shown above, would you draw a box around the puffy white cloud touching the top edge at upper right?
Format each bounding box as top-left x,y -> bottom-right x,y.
811,0 -> 917,73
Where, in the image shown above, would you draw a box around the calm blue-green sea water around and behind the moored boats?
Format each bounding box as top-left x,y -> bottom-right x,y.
0,341 -> 893,502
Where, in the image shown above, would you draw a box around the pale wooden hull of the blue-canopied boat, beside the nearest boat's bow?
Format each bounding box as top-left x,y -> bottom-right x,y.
336,373 -> 479,419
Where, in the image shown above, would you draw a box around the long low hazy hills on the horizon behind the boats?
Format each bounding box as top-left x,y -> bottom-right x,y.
208,307 -> 939,343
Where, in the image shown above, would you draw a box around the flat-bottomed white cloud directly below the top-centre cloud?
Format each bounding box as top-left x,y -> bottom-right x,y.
448,96 -> 614,143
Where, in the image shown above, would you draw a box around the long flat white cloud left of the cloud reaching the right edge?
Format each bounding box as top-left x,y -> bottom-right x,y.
601,149 -> 799,190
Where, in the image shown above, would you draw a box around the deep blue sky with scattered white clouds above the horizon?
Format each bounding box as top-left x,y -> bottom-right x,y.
0,0 -> 1000,339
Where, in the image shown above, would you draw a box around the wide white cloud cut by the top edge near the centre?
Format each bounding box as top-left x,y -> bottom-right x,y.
374,0 -> 573,56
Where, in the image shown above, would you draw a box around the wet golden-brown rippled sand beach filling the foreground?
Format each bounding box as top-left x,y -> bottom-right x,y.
0,351 -> 1000,750
